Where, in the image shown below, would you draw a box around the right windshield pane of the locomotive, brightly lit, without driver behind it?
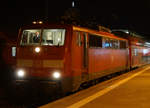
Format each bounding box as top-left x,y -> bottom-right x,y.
42,29 -> 65,46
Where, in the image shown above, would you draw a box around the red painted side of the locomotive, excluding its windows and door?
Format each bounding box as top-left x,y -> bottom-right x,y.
71,28 -> 129,77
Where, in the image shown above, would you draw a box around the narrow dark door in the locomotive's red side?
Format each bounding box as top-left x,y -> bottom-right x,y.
81,32 -> 89,81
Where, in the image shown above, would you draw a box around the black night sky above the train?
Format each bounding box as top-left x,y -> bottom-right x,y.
0,0 -> 150,37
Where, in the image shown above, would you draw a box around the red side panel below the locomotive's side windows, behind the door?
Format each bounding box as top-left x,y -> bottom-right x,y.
89,48 -> 128,73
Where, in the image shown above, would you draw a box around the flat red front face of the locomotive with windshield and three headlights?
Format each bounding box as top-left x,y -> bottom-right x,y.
14,26 -> 71,100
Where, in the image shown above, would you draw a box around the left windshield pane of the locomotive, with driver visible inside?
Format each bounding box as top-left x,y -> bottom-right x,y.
20,29 -> 41,45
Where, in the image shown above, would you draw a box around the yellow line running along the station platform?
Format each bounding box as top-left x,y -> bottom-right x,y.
67,67 -> 150,108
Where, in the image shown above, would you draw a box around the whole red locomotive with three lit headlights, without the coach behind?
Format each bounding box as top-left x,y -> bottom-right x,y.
15,24 -> 130,93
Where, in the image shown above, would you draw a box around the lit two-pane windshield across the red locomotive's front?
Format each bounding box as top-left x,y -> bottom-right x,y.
20,29 -> 65,46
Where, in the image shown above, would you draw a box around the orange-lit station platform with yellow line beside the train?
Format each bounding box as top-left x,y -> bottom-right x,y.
39,65 -> 150,108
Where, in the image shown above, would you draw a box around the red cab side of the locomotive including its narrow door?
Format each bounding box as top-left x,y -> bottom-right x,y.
71,31 -> 89,90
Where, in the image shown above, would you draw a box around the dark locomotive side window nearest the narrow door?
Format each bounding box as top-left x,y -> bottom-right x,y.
89,34 -> 102,47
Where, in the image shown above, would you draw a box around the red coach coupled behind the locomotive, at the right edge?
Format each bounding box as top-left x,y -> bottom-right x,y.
112,29 -> 150,68
